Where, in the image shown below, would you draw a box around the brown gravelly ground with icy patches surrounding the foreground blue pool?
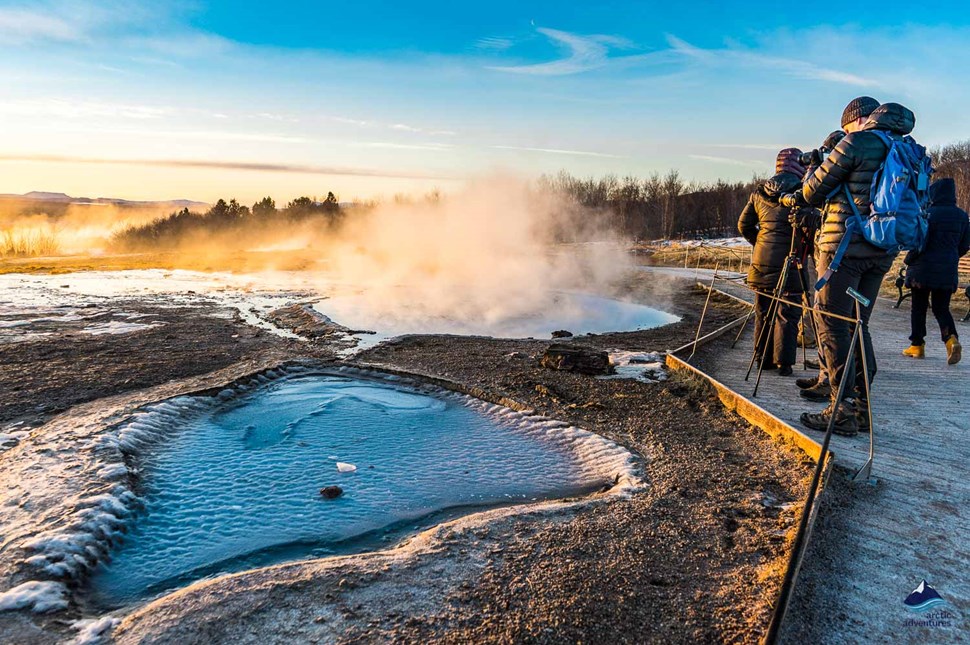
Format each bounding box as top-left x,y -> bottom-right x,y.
0,266 -> 810,643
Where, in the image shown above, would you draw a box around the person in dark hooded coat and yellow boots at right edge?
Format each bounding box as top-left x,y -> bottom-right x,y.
903,179 -> 970,365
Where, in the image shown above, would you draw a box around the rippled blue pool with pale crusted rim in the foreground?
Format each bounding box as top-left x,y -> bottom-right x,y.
90,373 -> 629,607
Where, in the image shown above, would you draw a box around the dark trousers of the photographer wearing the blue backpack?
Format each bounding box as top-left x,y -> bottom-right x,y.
817,253 -> 895,399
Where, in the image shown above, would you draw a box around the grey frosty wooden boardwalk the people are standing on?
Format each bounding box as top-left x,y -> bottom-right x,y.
656,270 -> 970,643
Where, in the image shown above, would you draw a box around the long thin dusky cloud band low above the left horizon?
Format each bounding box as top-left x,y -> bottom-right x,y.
0,155 -> 461,179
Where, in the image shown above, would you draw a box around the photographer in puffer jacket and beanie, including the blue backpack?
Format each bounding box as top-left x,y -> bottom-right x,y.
801,97 -> 931,436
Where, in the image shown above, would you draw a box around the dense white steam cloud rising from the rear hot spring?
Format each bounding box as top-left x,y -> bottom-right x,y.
321,177 -> 630,329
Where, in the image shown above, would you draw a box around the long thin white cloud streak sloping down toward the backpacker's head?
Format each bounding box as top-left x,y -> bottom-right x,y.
667,34 -> 879,87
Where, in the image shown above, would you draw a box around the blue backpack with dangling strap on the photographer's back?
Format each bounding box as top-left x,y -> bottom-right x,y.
815,130 -> 933,289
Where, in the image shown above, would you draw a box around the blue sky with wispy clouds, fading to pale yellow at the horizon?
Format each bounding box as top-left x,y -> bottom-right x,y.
0,0 -> 970,201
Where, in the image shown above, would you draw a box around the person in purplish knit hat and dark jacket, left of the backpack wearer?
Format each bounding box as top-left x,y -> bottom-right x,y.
738,148 -> 805,376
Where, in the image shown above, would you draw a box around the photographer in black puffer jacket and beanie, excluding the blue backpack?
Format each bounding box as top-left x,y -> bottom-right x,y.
801,97 -> 916,436
